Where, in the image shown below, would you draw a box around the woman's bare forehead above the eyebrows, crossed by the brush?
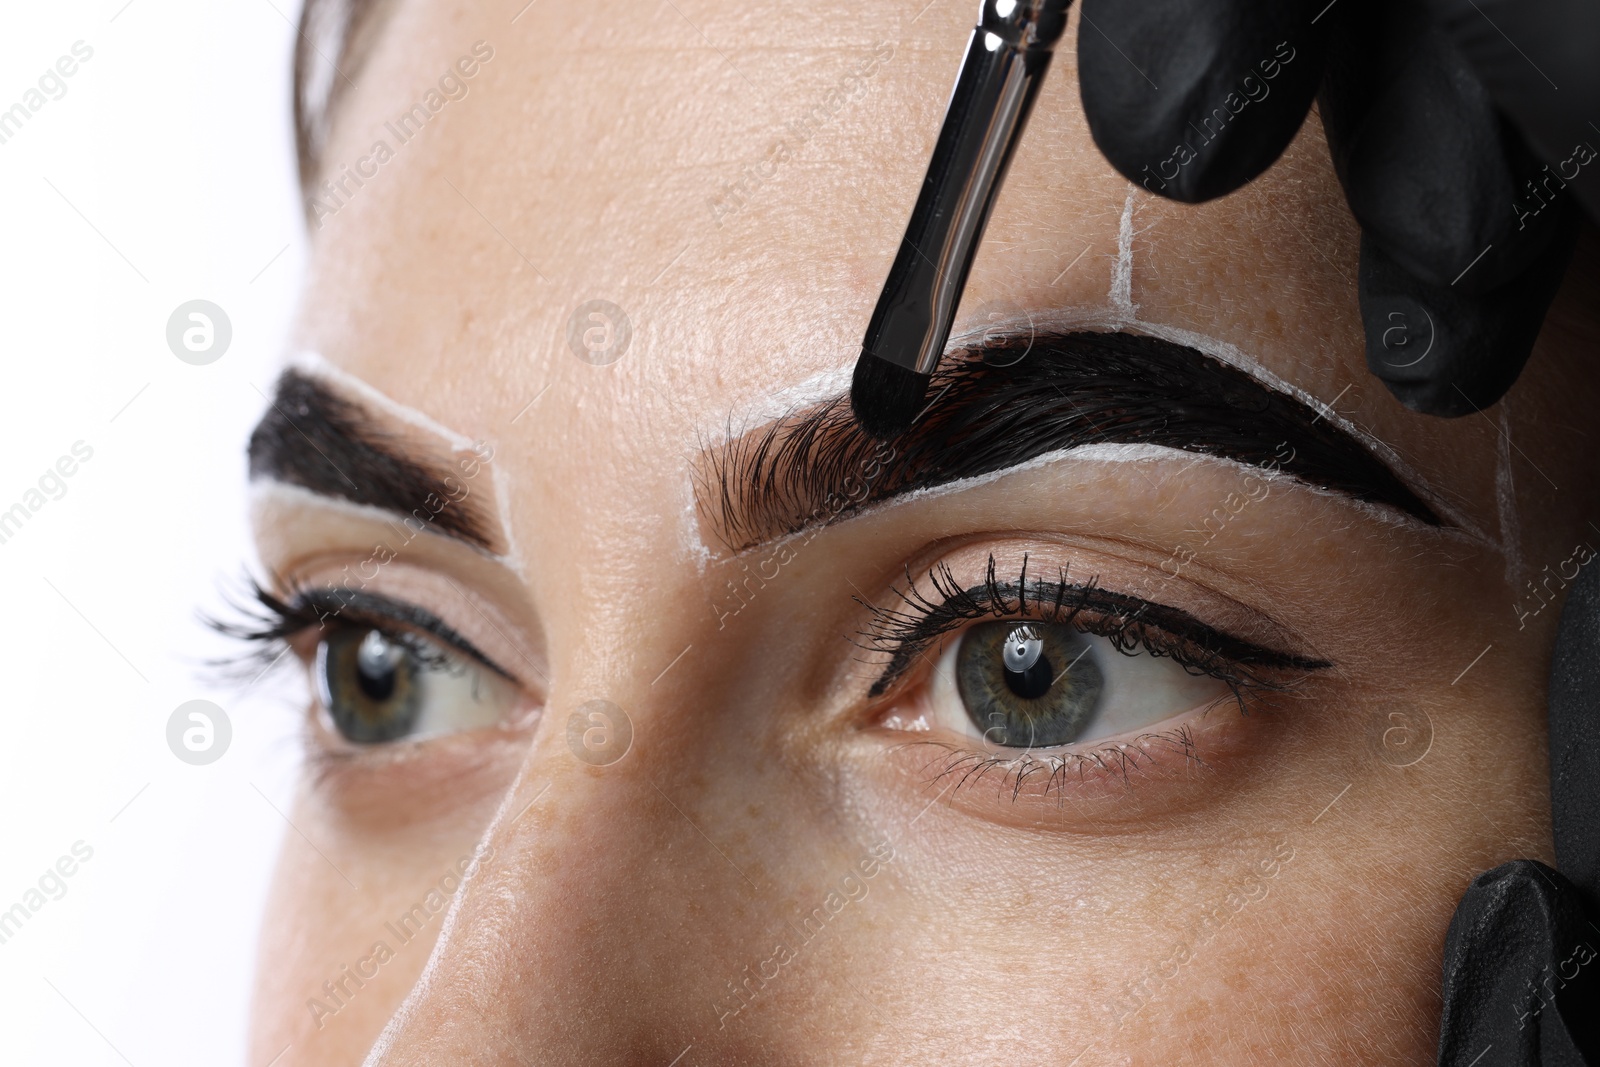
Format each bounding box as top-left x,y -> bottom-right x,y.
291,0 -> 1472,531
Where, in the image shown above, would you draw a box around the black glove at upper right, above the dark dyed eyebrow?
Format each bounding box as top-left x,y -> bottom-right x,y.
1078,0 -> 1600,414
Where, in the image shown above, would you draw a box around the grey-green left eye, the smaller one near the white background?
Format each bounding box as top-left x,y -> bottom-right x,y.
314,625 -> 517,744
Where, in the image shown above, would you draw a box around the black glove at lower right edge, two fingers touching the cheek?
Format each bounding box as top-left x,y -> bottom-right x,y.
1438,566 -> 1600,1067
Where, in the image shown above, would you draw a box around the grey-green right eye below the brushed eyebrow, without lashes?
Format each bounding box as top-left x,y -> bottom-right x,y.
928,621 -> 1232,750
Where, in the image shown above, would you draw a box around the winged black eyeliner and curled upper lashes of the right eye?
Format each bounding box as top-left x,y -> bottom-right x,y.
856,555 -> 1333,702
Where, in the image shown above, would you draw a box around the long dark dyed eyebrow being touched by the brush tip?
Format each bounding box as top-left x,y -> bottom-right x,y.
696,333 -> 1442,550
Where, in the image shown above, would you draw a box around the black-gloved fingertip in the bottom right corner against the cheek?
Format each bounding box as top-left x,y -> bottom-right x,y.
1437,859 -> 1600,1067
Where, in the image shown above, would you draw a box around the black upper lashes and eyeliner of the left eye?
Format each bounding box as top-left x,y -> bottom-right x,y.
206,579 -> 515,681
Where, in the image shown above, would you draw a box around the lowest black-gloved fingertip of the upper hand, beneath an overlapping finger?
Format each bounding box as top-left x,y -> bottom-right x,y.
1358,220 -> 1578,416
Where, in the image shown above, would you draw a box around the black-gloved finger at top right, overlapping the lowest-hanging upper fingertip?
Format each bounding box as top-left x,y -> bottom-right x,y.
1322,0 -> 1573,294
